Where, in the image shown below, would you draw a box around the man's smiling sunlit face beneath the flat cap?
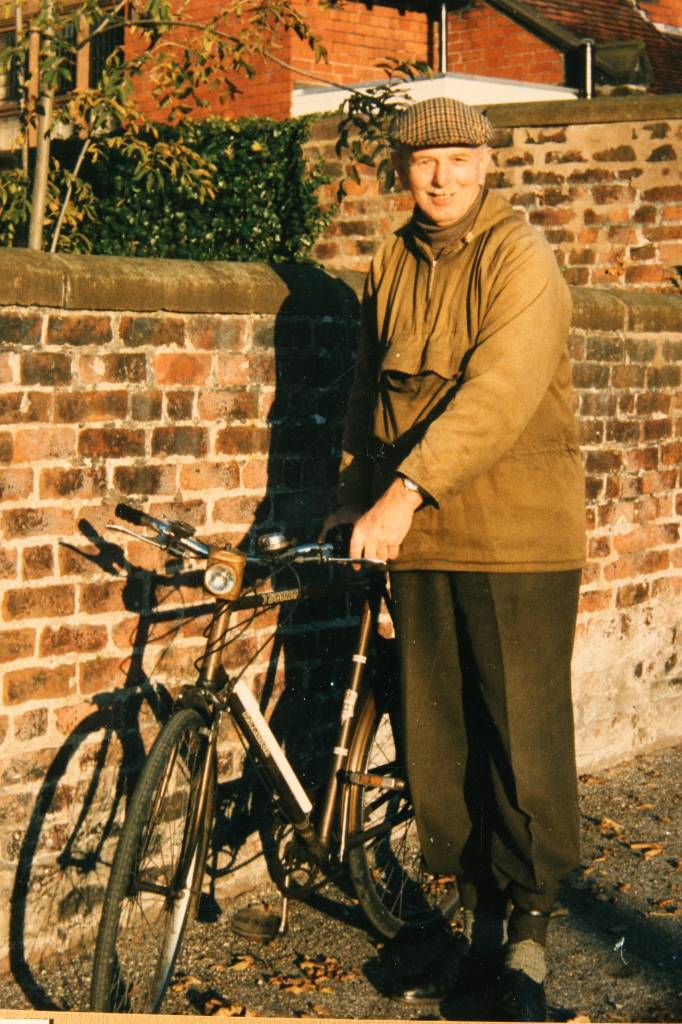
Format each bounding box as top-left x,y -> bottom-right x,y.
395,145 -> 493,224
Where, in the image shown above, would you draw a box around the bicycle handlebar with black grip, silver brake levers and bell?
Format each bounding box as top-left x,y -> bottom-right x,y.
109,503 -> 386,569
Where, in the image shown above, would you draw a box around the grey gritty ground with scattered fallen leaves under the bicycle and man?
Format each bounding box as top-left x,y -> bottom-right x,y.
0,746 -> 682,1021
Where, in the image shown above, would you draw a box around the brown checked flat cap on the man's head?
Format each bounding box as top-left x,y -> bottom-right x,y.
389,96 -> 495,150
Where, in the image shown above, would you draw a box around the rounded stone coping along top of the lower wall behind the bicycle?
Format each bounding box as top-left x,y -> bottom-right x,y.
0,249 -> 682,329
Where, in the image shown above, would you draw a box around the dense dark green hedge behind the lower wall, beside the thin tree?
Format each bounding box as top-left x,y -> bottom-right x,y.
0,118 -> 330,262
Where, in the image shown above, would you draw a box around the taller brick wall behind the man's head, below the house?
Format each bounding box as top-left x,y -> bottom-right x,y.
308,96 -> 682,292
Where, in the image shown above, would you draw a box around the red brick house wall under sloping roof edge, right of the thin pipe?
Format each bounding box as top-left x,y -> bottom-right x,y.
447,0 -> 564,85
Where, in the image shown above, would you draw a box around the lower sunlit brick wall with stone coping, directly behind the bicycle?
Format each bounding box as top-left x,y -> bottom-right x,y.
0,250 -> 682,983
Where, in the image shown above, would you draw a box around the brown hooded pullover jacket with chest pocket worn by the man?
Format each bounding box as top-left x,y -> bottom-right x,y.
339,194 -> 585,571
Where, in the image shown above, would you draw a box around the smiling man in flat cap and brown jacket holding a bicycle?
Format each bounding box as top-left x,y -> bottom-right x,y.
327,97 -> 585,1020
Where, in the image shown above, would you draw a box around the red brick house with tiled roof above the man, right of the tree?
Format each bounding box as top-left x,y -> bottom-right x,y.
288,0 -> 682,119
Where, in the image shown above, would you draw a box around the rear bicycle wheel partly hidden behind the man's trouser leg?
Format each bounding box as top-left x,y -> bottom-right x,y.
348,692 -> 459,938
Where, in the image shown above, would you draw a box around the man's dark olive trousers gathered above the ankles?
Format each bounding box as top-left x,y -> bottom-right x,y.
391,570 -> 581,913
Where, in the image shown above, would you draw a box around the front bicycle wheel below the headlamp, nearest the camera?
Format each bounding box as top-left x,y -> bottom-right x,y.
90,709 -> 215,1013
